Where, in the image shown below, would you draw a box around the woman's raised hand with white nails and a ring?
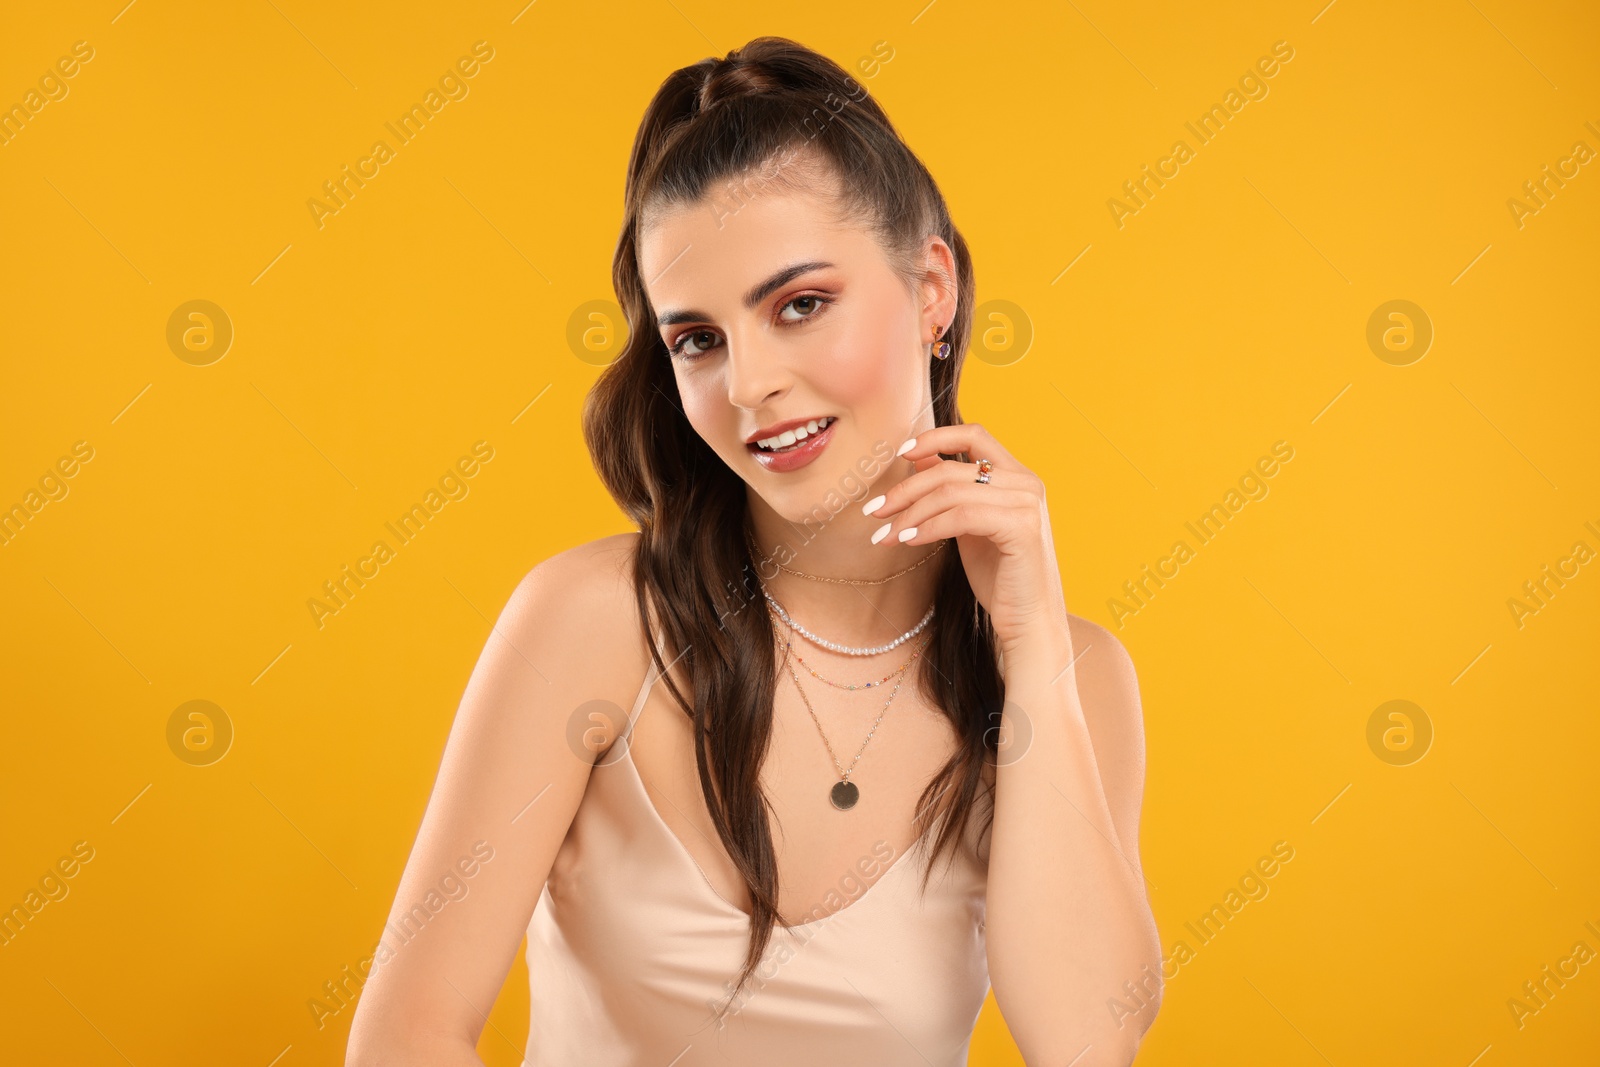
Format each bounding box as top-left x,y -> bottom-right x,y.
870,422 -> 1070,659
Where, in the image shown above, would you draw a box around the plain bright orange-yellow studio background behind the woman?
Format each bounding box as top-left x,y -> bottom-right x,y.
0,0 -> 1600,1067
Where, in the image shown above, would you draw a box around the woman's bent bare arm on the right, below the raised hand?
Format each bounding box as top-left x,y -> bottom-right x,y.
987,616 -> 1162,1067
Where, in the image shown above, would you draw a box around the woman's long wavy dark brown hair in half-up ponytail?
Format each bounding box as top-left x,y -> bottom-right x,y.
584,37 -> 1003,1003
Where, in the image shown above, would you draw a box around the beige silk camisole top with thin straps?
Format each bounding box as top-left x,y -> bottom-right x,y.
525,639 -> 989,1067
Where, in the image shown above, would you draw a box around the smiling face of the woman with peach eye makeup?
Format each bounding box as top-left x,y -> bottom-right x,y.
638,173 -> 955,522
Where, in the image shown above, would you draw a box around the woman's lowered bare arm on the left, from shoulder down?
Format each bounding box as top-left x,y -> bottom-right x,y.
346,534 -> 648,1067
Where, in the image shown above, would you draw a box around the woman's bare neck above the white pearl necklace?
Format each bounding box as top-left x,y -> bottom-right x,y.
750,499 -> 952,654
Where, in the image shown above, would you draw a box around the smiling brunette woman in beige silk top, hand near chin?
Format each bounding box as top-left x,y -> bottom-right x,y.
347,37 -> 1160,1067
